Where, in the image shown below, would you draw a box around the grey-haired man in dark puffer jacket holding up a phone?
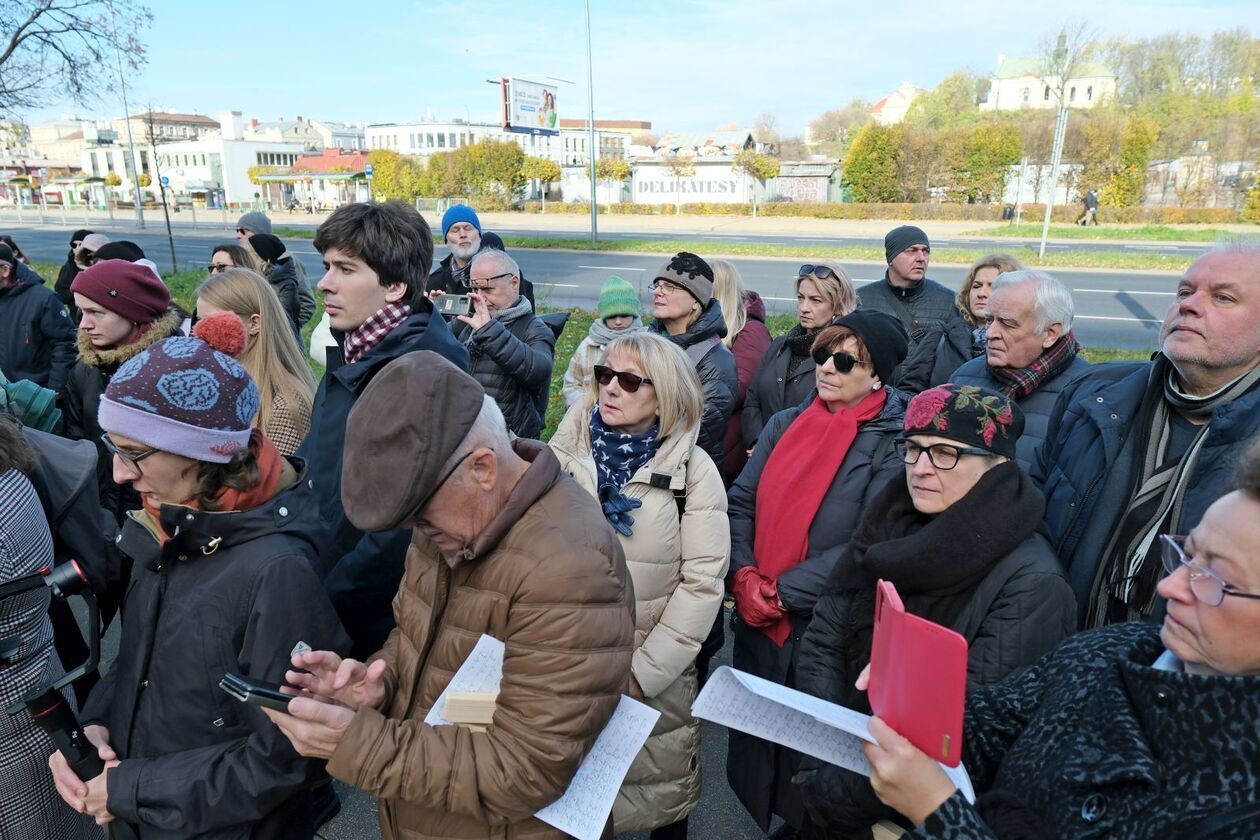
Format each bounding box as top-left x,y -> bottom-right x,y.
452,248 -> 556,438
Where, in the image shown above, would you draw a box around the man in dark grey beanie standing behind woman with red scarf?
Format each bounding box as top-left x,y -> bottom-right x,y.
858,224 -> 954,385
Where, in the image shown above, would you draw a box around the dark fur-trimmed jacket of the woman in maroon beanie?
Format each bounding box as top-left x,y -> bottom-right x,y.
62,310 -> 183,525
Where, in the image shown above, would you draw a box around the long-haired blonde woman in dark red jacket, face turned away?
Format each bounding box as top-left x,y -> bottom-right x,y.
709,259 -> 770,486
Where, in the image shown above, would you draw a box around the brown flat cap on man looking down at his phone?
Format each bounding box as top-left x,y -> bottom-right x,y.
341,350 -> 485,531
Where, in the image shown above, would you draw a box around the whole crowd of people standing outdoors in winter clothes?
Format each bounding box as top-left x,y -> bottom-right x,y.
0,201 -> 1260,840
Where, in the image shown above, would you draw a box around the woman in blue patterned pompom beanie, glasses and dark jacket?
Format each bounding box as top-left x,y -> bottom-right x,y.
49,336 -> 349,840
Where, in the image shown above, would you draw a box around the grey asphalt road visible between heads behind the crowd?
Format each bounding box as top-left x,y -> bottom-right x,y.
9,227 -> 1176,349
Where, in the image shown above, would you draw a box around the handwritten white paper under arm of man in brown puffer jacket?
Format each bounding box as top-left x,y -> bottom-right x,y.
425,635 -> 660,840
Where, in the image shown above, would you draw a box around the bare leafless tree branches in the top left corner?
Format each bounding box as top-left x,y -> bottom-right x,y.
0,0 -> 152,113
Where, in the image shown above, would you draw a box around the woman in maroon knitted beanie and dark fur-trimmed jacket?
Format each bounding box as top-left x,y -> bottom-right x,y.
63,259 -> 183,528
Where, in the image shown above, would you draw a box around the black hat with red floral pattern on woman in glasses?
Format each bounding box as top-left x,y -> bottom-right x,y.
905,383 -> 1024,458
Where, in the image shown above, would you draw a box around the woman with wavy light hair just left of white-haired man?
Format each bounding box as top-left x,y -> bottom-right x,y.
897,253 -> 1023,394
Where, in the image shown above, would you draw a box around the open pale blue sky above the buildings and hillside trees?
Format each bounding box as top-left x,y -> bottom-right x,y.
17,0 -> 1260,136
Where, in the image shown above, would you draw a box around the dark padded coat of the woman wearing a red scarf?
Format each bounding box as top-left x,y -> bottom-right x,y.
726,388 -> 906,831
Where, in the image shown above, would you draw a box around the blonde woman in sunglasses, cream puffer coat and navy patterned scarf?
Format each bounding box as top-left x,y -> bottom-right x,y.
551,332 -> 731,840
